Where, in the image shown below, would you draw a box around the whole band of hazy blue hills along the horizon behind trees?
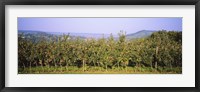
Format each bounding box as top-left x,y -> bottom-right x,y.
18,30 -> 156,39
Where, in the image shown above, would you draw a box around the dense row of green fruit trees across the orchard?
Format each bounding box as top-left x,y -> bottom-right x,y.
18,30 -> 182,72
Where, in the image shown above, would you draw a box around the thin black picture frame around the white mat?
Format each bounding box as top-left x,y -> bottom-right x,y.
0,0 -> 200,92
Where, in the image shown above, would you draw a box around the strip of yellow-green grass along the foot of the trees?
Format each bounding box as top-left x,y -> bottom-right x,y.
18,66 -> 182,74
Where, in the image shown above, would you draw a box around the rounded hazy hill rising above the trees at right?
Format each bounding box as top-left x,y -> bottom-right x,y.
126,30 -> 156,39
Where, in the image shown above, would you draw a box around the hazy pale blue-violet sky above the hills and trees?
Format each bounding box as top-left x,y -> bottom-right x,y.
18,17 -> 182,34
